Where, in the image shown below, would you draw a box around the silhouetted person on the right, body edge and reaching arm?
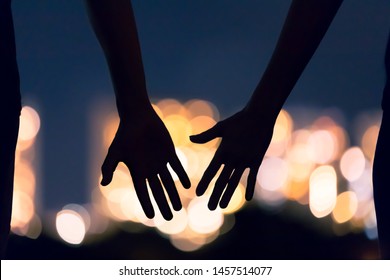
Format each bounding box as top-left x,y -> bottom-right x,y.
190,0 -> 390,259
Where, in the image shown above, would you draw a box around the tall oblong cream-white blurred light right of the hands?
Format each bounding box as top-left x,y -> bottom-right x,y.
309,165 -> 337,218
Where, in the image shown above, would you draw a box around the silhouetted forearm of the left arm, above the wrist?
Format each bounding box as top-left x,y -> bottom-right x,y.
85,0 -> 150,117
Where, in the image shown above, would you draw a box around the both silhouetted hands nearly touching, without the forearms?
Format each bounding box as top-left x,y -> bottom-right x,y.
101,106 -> 273,220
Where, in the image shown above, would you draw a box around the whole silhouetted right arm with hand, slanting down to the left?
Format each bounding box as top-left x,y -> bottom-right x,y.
191,0 -> 342,209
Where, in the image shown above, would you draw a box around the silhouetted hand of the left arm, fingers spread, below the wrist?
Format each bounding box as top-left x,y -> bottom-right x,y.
101,108 -> 191,220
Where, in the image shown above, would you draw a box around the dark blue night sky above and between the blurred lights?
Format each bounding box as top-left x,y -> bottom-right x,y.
13,0 -> 390,208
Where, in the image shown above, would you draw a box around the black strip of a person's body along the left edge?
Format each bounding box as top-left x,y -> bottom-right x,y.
0,0 -> 21,258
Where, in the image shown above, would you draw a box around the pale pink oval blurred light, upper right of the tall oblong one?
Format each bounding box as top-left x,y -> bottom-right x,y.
340,147 -> 366,182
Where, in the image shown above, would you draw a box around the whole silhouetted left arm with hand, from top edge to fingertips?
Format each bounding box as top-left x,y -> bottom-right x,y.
85,0 -> 190,220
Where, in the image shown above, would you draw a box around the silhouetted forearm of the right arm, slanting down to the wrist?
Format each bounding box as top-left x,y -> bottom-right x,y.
246,0 -> 342,117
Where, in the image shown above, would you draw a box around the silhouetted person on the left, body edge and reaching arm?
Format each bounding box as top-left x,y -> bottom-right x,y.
0,0 -> 191,258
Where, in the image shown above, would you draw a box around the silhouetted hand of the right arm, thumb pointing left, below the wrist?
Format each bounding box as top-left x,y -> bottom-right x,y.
190,110 -> 275,210
